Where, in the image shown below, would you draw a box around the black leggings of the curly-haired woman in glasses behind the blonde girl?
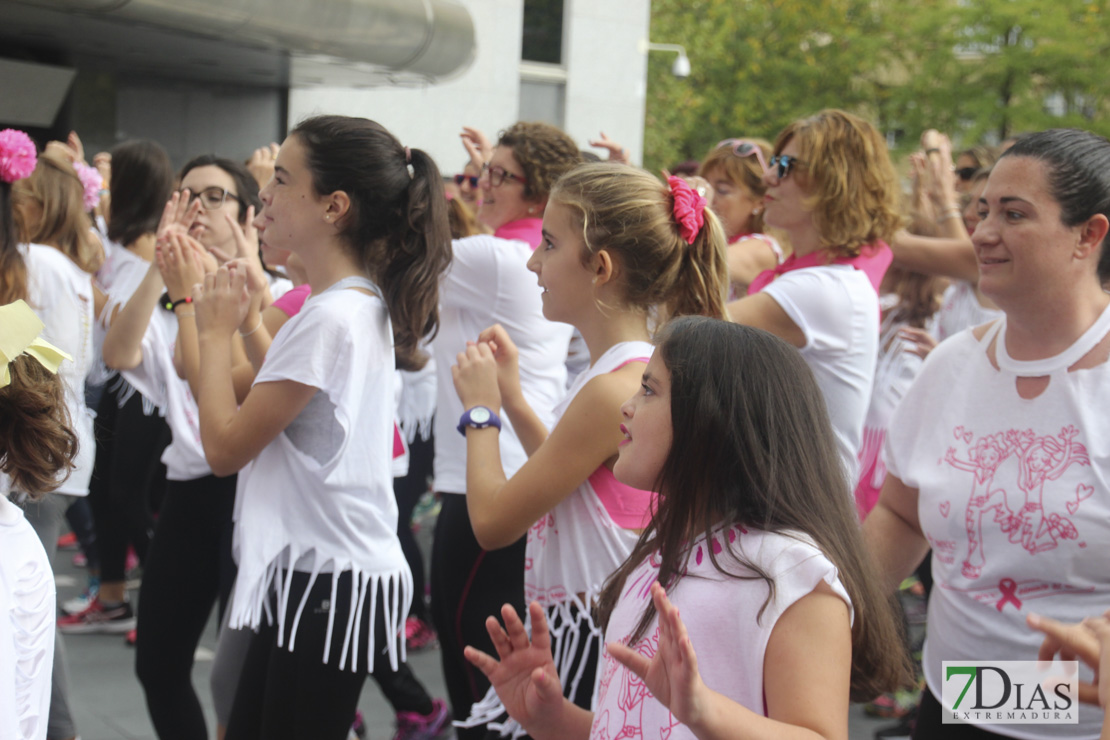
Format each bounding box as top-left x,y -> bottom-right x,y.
432,494 -> 527,740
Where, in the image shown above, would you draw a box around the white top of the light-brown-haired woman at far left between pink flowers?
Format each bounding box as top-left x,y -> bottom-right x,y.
20,244 -> 97,496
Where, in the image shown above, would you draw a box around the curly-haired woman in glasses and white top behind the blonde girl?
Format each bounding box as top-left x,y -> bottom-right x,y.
431,123 -> 581,740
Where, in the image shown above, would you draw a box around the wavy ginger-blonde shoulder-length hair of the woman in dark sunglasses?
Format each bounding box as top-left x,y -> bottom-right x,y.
775,109 -> 902,256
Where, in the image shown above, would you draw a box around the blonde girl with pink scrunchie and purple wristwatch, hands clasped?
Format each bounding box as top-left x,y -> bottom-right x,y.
452,163 -> 728,734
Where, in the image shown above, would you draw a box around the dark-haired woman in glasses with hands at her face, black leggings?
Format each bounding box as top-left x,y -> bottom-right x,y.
93,156 -> 259,738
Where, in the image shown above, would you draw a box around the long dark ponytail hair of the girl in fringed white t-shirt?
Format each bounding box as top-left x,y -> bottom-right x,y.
291,115 -> 451,371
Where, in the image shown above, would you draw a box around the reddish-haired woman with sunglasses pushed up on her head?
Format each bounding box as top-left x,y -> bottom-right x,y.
698,139 -> 784,297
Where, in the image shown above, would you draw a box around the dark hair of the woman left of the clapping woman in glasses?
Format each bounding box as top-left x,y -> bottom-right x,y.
108,139 -> 173,246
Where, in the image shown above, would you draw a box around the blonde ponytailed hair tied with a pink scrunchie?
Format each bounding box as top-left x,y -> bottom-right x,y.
551,162 -> 728,321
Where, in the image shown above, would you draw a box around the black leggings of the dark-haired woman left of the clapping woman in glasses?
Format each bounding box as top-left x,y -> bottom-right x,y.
89,376 -> 170,584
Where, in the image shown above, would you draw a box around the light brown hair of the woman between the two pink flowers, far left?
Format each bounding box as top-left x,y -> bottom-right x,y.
12,155 -> 104,273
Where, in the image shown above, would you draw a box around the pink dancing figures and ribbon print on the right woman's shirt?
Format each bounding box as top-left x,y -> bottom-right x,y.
940,425 -> 1094,611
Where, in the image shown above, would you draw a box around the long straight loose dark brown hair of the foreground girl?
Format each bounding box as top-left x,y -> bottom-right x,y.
598,316 -> 911,701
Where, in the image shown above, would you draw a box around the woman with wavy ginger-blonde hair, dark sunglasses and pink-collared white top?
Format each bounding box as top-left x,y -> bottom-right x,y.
729,110 -> 901,486
